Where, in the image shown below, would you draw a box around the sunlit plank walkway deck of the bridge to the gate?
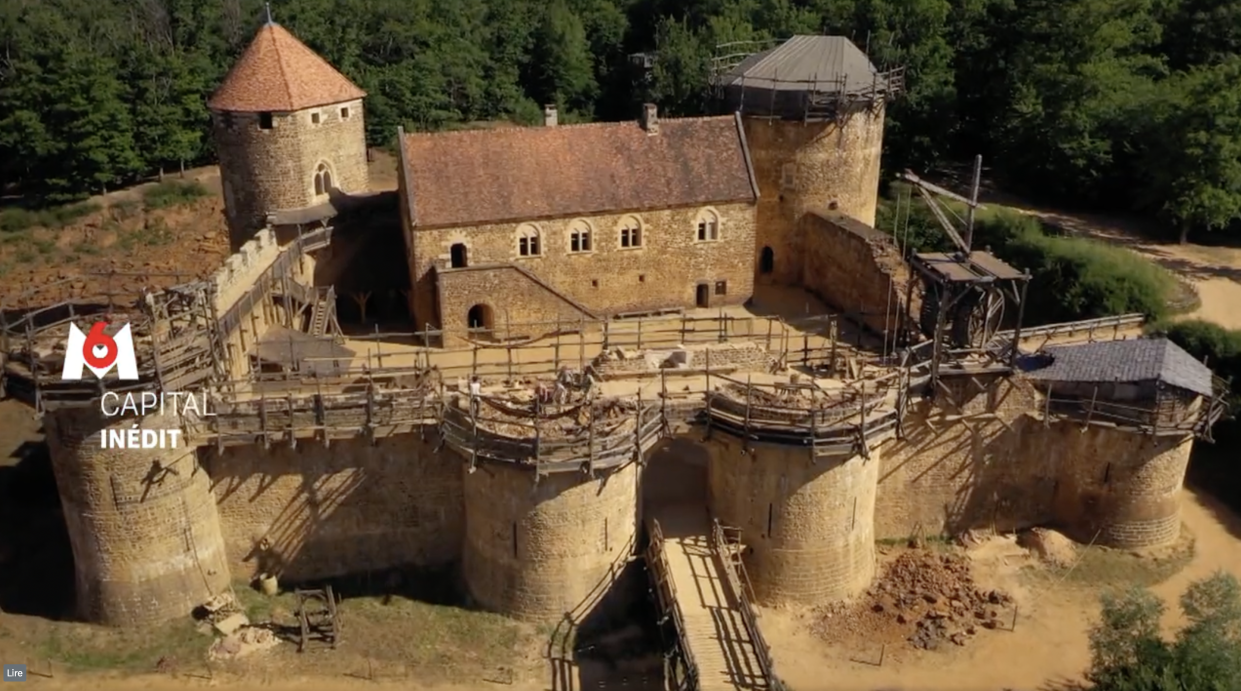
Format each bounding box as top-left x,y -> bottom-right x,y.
650,506 -> 769,691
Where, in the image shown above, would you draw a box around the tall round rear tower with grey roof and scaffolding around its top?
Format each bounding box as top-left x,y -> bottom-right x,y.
714,36 -> 902,284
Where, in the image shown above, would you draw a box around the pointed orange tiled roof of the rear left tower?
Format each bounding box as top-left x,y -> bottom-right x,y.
207,22 -> 366,113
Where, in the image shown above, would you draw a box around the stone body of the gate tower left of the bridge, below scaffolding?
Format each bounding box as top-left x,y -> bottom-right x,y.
463,461 -> 638,623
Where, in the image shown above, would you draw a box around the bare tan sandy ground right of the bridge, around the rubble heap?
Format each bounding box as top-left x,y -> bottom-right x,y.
762,483 -> 1241,691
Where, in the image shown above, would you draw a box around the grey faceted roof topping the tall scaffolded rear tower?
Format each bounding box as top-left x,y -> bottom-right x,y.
721,36 -> 885,93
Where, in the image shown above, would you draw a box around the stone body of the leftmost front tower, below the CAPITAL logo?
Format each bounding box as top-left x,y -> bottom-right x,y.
43,404 -> 230,626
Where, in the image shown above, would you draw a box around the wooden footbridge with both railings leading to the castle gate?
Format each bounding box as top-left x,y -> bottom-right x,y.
647,506 -> 781,691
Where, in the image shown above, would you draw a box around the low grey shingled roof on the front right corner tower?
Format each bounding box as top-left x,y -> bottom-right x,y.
1029,339 -> 1214,396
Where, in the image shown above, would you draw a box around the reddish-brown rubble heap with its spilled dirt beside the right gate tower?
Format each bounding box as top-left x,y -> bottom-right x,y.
817,550 -> 1013,650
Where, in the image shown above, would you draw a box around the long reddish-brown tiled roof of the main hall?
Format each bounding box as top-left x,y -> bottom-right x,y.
401,115 -> 758,227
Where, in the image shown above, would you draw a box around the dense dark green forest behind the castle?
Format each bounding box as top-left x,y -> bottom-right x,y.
0,0 -> 1241,241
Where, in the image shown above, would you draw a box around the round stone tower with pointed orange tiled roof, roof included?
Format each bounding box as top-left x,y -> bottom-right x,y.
207,21 -> 370,252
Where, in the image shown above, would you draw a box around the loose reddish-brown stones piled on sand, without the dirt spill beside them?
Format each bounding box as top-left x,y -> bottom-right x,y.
866,550 -> 1013,650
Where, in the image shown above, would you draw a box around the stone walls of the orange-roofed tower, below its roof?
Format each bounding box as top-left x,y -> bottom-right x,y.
212,99 -> 370,249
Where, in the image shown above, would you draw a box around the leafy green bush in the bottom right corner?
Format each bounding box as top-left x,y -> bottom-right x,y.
1087,572 -> 1241,691
